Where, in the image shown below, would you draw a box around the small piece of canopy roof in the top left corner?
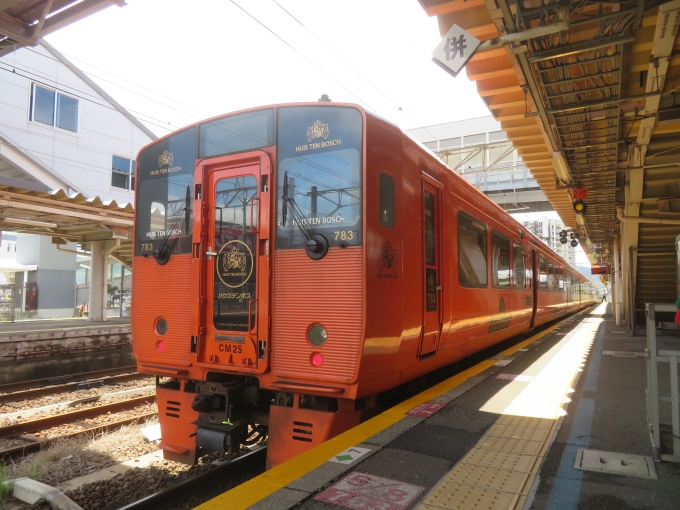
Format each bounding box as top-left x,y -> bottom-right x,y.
0,0 -> 127,57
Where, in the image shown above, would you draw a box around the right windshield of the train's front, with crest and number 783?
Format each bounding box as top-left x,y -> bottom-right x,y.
276,106 -> 362,249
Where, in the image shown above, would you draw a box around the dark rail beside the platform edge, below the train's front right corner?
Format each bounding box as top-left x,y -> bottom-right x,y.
118,446 -> 267,510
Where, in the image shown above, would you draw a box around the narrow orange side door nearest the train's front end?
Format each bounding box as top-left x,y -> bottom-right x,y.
420,182 -> 442,359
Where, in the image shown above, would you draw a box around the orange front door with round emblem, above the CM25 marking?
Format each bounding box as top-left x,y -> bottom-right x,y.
200,152 -> 271,372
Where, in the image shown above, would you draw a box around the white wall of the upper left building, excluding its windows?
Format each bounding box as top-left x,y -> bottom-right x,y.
0,46 -> 152,203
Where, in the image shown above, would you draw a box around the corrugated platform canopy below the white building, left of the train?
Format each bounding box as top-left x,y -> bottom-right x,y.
0,183 -> 134,266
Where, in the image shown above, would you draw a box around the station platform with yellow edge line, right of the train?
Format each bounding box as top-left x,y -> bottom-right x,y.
198,303 -> 680,510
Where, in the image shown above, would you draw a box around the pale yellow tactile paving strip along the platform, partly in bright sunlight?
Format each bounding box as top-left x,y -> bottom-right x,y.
418,308 -> 601,510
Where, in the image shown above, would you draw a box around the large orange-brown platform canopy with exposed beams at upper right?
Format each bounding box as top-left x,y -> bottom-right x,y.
419,0 -> 680,324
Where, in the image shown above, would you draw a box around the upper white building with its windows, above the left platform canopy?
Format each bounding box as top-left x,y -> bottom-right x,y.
0,41 -> 156,199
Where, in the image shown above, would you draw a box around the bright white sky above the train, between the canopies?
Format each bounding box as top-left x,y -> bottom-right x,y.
46,0 -> 490,136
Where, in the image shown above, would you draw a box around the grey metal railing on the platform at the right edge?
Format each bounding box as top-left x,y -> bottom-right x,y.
645,303 -> 680,462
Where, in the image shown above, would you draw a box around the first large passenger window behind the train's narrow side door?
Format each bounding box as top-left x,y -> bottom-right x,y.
458,212 -> 487,287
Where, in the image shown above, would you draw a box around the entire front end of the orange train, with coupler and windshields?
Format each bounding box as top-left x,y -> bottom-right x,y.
132,103 -> 364,466
